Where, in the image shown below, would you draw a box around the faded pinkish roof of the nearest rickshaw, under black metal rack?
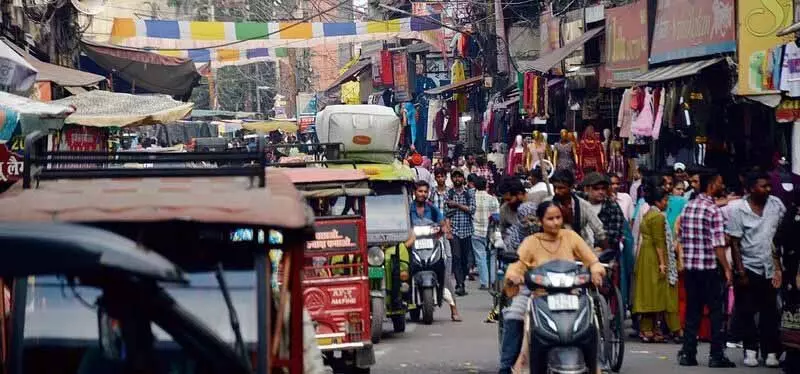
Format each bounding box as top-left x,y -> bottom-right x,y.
0,170 -> 313,229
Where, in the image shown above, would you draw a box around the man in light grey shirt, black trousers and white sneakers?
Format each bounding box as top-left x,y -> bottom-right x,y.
725,173 -> 786,367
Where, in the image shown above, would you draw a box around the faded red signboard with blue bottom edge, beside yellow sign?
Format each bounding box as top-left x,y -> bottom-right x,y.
650,0 -> 736,64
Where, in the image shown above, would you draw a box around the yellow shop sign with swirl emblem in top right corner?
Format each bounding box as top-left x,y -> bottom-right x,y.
737,0 -> 794,95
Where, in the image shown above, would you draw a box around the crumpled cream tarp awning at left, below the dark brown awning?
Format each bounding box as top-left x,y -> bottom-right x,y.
52,90 -> 194,127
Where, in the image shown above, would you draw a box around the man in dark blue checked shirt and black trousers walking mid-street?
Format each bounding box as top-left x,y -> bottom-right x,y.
445,169 -> 475,296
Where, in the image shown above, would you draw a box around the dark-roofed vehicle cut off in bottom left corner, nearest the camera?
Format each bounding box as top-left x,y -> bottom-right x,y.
0,222 -> 216,374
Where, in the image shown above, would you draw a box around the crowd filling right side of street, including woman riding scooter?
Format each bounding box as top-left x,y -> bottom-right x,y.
407,149 -> 800,373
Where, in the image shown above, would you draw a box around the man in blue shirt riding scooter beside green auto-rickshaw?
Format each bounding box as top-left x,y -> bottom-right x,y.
405,180 -> 461,322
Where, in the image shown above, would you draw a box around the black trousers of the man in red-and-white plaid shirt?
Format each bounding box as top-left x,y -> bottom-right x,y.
681,270 -> 724,358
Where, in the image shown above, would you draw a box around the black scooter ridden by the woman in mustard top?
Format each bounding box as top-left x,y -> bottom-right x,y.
525,260 -> 598,374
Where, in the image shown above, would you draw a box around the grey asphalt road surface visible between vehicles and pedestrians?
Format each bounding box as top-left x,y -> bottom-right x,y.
372,282 -> 782,374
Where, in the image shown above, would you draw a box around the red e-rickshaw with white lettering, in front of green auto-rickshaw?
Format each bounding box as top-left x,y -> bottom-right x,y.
281,168 -> 376,373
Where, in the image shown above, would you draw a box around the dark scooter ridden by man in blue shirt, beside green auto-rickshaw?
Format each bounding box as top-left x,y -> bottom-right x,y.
409,224 -> 445,325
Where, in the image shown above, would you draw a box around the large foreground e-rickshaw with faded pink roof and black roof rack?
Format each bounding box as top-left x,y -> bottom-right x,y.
0,133 -> 314,374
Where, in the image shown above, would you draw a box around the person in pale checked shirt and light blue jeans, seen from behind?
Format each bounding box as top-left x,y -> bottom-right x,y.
472,177 -> 500,290
